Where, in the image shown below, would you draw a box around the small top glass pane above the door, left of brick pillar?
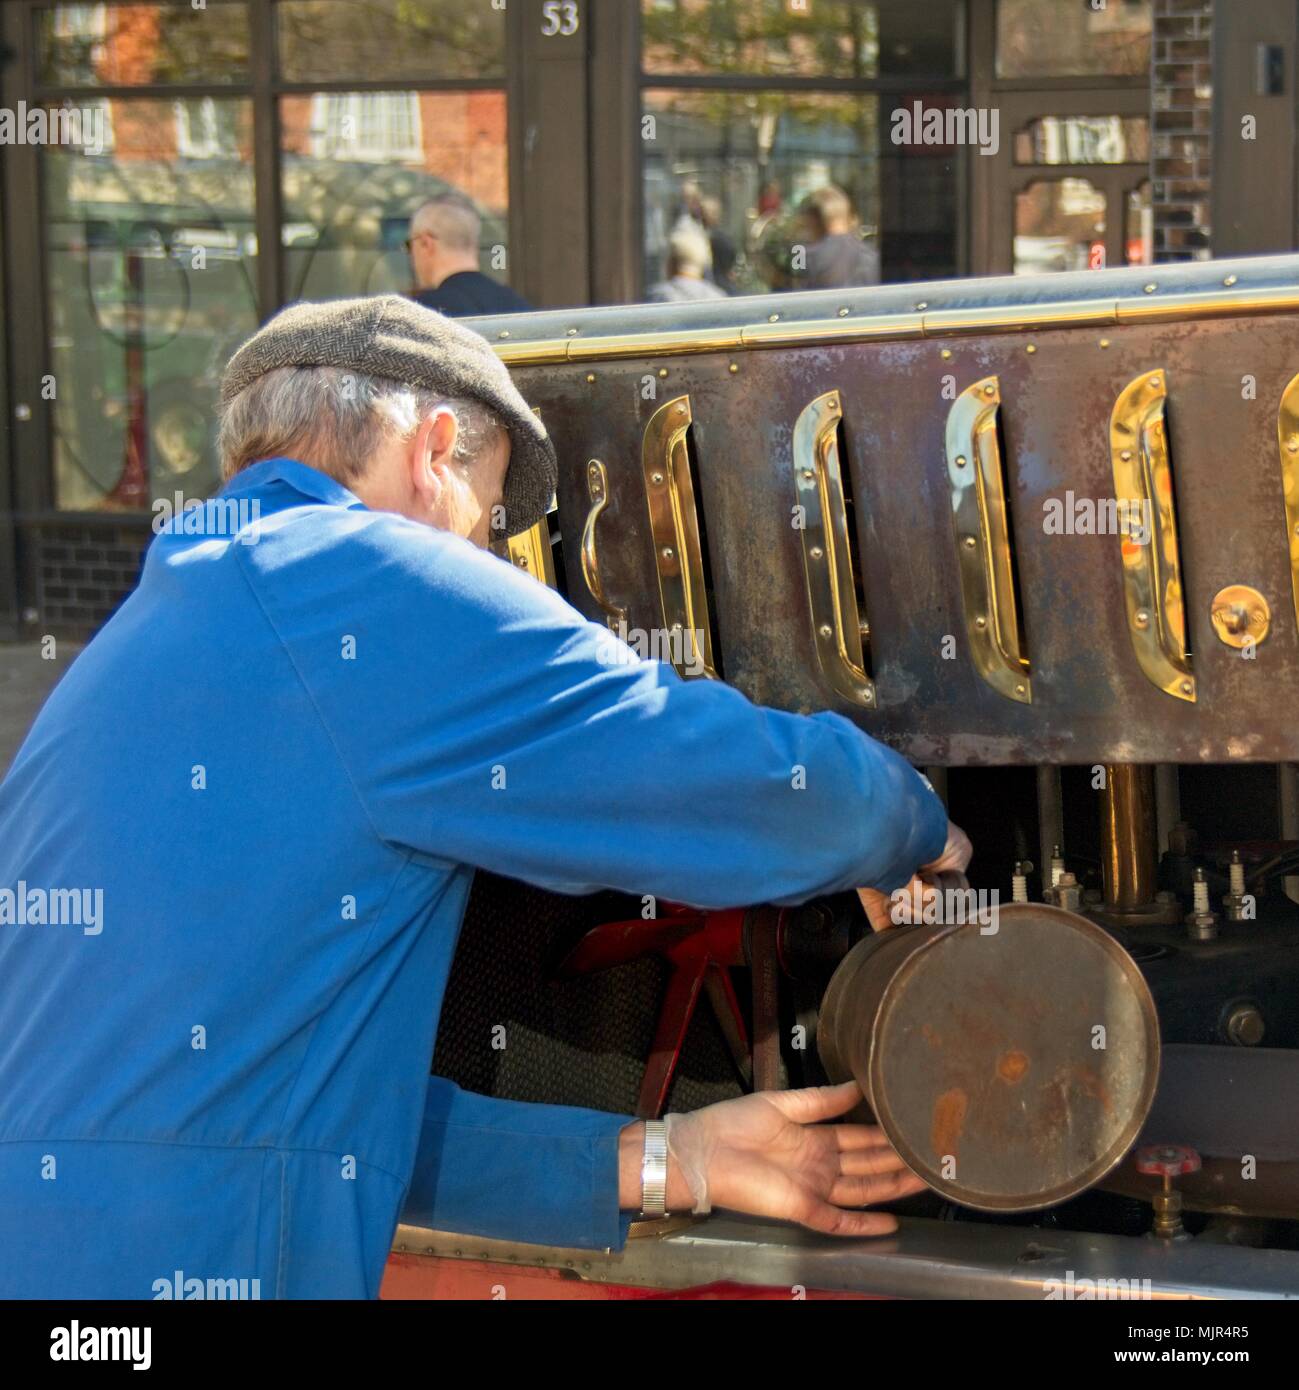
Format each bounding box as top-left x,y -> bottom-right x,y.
996,0 -> 1150,78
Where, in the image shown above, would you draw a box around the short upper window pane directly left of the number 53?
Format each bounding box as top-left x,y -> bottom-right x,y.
275,0 -> 506,82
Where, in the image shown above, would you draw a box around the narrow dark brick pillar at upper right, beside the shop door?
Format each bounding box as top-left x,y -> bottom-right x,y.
1150,0 -> 1214,261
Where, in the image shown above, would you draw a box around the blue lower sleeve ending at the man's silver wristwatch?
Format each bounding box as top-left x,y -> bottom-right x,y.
402,1076 -> 632,1250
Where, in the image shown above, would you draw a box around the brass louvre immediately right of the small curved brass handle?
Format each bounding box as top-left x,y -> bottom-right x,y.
640,396 -> 717,680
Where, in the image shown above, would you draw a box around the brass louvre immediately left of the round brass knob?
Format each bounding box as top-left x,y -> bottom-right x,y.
1110,370 -> 1195,703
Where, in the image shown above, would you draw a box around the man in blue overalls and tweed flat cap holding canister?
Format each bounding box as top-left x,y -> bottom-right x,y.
0,296 -> 968,1298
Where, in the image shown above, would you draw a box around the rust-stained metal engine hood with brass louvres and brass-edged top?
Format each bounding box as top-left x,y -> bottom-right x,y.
474,257 -> 1299,766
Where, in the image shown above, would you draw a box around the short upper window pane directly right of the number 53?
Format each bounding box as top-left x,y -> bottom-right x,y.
640,0 -> 959,78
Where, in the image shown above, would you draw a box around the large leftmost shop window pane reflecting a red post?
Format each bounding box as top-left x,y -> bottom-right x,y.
42,97 -> 257,510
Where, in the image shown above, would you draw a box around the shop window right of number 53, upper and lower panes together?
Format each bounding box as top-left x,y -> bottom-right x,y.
640,0 -> 964,299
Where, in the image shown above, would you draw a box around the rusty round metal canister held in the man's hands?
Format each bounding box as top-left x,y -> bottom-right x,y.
817,904 -> 1159,1212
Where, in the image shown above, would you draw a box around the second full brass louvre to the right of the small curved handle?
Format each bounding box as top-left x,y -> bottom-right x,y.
793,391 -> 875,706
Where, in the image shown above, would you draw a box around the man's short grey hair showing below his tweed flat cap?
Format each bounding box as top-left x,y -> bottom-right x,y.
218,367 -> 506,484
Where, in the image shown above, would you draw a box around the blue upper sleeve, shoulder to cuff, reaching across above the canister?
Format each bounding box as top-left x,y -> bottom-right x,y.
272,516 -> 948,908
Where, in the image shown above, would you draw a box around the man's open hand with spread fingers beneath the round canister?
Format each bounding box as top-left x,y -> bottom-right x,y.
624,1081 -> 925,1236
